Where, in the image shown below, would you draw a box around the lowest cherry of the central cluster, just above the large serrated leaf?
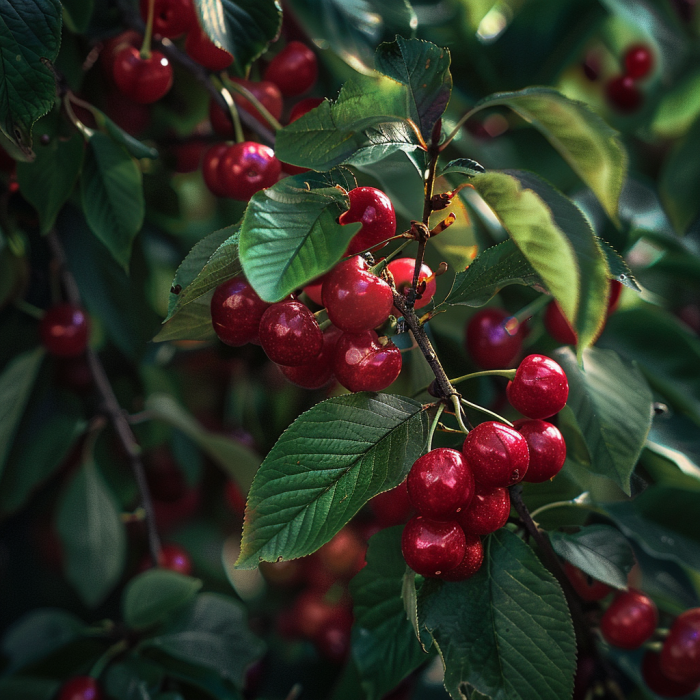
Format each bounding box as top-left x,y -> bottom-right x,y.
333,331 -> 402,391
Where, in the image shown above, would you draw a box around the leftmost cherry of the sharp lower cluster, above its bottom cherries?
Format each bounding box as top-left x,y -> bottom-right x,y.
407,447 -> 474,520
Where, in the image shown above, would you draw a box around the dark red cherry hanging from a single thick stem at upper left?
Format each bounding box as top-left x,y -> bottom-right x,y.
114,46 -> 173,104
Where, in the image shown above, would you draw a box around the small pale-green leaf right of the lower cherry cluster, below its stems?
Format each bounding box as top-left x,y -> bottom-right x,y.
549,525 -> 635,589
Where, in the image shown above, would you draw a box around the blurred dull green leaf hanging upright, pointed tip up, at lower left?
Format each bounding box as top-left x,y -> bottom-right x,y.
56,461 -> 126,607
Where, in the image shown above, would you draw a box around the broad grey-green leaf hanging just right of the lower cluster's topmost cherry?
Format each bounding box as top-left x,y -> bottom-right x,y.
553,347 -> 653,495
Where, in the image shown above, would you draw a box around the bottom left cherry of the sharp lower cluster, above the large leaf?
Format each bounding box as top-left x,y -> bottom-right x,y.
401,515 -> 467,578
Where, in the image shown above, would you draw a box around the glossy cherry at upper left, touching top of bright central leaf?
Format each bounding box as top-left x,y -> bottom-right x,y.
218,141 -> 282,202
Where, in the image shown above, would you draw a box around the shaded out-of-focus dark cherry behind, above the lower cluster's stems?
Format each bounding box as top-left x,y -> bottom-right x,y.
465,308 -> 523,369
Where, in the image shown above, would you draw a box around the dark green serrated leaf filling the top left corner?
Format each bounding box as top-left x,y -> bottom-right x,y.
0,0 -> 61,153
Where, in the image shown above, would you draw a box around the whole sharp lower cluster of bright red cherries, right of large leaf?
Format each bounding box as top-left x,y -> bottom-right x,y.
401,355 -> 569,581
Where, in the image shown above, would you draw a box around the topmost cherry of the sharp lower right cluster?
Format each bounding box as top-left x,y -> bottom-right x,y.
506,355 -> 569,420
